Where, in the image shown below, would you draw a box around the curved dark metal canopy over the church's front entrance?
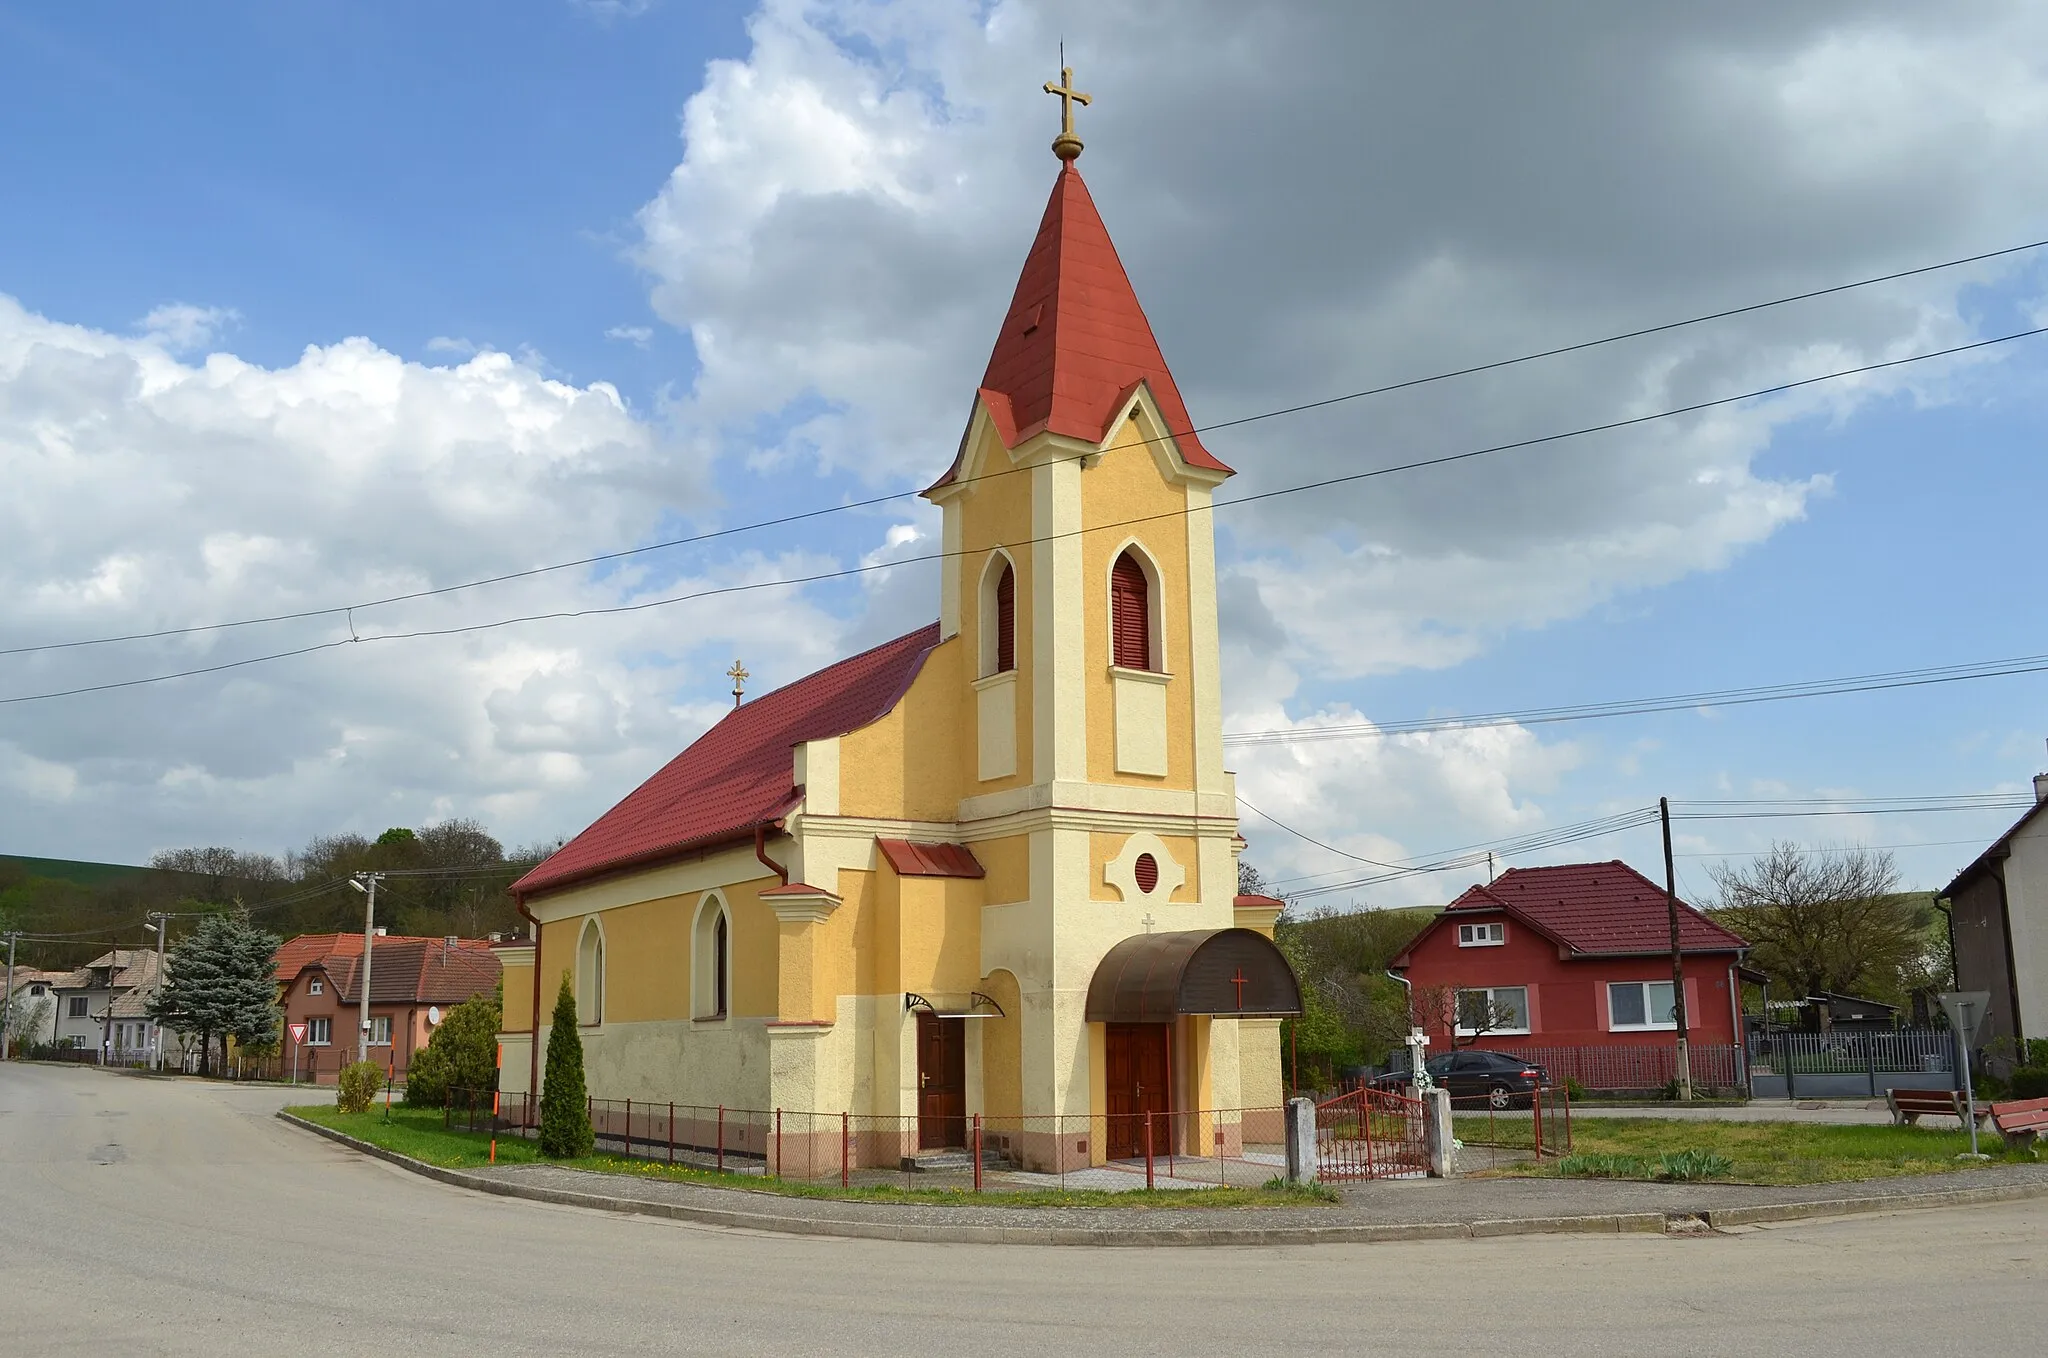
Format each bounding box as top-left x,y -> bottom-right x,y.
1087,928 -> 1300,1024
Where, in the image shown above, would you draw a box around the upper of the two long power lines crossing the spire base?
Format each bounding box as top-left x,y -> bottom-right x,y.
0,240 -> 2048,655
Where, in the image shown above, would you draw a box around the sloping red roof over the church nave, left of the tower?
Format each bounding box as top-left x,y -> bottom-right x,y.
512,623 -> 938,897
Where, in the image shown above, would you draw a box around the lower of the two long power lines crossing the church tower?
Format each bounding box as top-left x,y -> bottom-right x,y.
0,326 -> 2048,707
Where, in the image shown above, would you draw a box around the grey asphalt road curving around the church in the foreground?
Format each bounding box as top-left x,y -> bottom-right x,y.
0,1065 -> 2048,1358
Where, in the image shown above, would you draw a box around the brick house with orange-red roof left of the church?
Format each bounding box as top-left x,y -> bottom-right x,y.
276,934 -> 500,1079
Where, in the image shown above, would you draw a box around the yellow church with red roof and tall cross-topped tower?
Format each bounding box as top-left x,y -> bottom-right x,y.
500,74 -> 1300,1170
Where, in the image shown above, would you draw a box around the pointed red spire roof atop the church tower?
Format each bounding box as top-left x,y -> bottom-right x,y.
934,160 -> 1231,490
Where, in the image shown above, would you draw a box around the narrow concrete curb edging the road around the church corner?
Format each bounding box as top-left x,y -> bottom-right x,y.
276,1110 -> 2048,1247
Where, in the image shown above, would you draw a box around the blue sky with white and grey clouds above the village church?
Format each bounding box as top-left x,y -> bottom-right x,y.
0,0 -> 2048,903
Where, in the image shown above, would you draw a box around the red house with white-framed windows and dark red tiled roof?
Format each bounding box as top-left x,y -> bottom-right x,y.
1393,860 -> 1749,1088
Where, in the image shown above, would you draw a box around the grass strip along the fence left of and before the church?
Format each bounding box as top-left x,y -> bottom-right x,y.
287,1104 -> 1341,1206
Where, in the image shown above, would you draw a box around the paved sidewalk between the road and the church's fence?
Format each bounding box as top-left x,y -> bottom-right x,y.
279,1112 -> 2048,1245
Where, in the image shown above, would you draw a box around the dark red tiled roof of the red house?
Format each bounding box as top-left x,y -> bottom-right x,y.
1441,860 -> 1749,954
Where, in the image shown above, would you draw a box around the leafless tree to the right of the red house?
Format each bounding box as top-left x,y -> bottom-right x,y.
1710,844 -> 1931,995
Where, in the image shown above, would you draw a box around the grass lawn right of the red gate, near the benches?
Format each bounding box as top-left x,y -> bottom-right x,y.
1505,1116 -> 2036,1184
